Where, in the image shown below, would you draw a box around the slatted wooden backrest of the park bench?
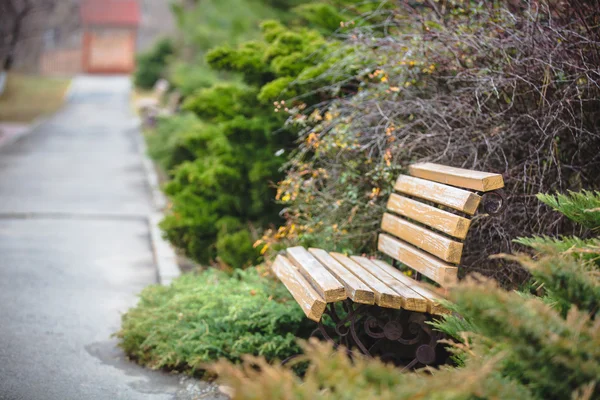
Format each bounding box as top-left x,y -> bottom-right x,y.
378,163 -> 504,286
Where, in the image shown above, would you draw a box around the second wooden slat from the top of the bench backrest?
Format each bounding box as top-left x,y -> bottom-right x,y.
394,175 -> 481,215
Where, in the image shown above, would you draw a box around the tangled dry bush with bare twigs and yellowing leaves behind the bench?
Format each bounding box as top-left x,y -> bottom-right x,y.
279,0 -> 600,284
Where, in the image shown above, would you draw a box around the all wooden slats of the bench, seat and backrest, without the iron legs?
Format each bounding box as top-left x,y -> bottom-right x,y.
273,163 -> 504,322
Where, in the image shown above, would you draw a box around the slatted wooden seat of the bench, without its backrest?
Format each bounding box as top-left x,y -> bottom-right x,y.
272,247 -> 448,322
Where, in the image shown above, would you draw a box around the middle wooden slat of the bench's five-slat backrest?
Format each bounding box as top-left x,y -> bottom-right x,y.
387,193 -> 471,239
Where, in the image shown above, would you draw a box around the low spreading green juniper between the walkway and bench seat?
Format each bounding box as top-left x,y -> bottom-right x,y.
117,268 -> 309,375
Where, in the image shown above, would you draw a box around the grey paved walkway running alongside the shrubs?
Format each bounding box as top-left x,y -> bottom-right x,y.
0,77 -> 225,400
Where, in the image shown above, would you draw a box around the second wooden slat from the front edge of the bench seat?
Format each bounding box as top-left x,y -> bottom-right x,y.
286,246 -> 347,303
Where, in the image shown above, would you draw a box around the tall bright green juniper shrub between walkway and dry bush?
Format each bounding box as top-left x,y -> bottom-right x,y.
153,21 -> 358,267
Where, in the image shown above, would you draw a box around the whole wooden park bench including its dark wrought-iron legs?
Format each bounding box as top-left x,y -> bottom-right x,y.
272,163 -> 504,368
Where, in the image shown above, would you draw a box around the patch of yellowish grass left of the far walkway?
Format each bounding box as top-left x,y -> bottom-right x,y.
0,72 -> 71,122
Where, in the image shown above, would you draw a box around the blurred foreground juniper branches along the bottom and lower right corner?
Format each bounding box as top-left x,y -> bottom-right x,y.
212,192 -> 600,400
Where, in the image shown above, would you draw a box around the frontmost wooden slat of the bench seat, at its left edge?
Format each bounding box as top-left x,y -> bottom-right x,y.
271,255 -> 327,322
